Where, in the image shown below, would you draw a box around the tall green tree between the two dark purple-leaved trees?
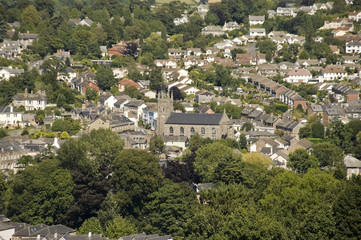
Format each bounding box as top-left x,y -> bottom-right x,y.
112,149 -> 163,215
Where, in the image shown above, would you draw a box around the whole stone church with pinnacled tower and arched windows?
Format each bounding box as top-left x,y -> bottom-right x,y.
157,93 -> 234,139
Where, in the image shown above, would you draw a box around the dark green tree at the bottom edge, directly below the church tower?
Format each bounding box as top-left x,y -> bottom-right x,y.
144,180 -> 197,237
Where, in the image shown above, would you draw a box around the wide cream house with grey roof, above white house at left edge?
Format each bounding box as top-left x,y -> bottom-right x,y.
13,90 -> 47,111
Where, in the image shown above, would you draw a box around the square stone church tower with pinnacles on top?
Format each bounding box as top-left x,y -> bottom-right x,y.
157,90 -> 174,136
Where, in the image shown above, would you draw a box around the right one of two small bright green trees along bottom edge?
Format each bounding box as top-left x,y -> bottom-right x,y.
104,216 -> 137,239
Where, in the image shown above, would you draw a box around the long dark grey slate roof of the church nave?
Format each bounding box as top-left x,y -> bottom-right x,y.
166,113 -> 223,125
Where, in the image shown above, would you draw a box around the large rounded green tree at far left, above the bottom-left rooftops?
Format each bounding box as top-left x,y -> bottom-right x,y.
7,159 -> 74,224
